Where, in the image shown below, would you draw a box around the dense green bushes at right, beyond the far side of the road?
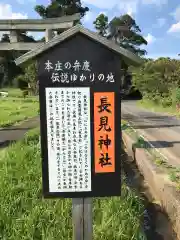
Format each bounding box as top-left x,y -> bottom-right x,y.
132,58 -> 180,112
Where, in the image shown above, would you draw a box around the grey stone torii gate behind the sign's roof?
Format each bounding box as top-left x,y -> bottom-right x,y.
0,13 -> 80,51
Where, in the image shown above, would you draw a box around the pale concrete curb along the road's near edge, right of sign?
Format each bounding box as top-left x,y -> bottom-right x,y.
122,132 -> 180,240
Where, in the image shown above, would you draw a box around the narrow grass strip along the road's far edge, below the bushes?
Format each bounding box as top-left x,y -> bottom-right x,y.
137,99 -> 180,117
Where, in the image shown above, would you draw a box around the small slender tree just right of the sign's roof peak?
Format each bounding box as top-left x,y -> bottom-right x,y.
93,13 -> 108,36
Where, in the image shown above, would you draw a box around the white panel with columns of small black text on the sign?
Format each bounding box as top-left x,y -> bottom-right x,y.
46,87 -> 91,192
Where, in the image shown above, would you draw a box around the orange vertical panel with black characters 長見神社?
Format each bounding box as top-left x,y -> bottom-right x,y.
94,92 -> 115,173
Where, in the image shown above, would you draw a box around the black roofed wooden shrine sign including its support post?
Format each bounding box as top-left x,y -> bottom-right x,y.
17,23 -> 142,240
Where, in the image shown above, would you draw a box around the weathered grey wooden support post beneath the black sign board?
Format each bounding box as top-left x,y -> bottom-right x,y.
72,198 -> 93,240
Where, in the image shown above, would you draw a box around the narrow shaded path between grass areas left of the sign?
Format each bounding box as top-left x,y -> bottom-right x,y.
0,116 -> 39,148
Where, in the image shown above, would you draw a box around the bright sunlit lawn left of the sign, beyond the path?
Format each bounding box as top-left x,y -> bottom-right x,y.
0,89 -> 39,128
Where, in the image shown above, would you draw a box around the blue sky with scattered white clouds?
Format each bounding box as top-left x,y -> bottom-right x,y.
0,0 -> 180,59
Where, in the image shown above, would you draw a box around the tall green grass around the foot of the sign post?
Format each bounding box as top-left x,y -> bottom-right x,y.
0,129 -> 145,240
